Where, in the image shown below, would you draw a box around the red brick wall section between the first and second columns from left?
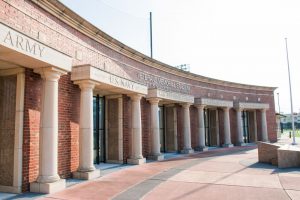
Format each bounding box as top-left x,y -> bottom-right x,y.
58,74 -> 80,178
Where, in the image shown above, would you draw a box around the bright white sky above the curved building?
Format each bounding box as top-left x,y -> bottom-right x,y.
61,0 -> 300,113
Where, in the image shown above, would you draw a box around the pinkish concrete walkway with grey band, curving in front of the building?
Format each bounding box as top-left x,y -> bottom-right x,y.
37,147 -> 300,200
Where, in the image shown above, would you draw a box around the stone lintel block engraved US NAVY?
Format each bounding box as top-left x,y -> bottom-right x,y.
71,65 -> 148,95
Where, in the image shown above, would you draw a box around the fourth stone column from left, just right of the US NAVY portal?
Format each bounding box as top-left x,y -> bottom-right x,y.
149,98 -> 164,160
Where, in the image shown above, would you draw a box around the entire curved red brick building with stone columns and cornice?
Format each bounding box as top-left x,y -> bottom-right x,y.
0,0 -> 276,193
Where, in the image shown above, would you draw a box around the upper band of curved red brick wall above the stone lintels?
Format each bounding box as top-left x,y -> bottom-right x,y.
0,0 -> 276,140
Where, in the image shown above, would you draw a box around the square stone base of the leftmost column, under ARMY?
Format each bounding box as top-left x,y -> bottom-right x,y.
30,179 -> 66,194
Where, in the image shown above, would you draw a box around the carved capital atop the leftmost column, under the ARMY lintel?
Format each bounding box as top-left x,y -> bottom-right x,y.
34,67 -> 67,81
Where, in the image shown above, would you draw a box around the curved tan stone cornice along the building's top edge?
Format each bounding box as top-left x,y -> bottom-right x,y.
32,0 -> 276,91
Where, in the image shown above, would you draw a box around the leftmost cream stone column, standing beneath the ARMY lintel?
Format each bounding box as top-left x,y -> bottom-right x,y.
30,67 -> 66,193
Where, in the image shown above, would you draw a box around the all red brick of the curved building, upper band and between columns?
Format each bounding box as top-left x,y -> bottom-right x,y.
0,0 -> 276,191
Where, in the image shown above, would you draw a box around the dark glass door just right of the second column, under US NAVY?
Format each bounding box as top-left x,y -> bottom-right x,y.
93,95 -> 105,164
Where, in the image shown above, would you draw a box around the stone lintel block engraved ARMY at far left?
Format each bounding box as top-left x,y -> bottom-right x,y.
0,22 -> 72,72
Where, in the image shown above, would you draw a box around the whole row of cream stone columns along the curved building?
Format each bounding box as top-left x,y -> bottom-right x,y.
31,68 -> 268,193
